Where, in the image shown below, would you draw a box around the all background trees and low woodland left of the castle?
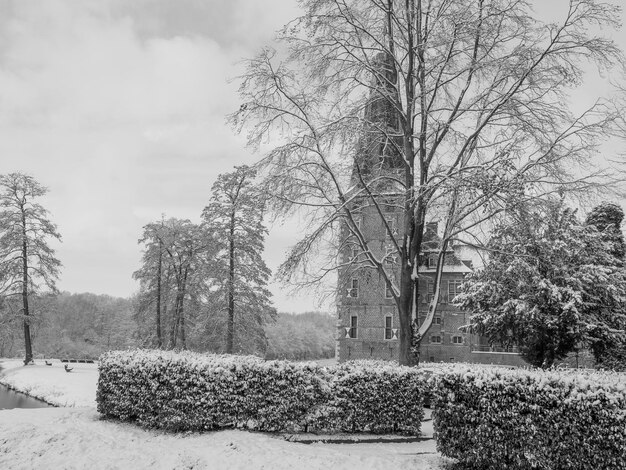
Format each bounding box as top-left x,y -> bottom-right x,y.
0,171 -> 334,363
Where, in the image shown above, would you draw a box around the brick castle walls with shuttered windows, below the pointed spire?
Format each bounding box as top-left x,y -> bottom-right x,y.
337,218 -> 524,366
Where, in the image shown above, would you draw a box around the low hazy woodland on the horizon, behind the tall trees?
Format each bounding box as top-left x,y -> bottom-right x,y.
0,292 -> 336,360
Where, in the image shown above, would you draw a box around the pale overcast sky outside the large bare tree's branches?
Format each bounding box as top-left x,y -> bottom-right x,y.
0,0 -> 626,311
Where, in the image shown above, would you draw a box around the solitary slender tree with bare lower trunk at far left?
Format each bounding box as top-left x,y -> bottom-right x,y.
0,173 -> 61,364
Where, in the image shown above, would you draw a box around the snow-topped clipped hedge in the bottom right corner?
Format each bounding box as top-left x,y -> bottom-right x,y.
431,367 -> 626,470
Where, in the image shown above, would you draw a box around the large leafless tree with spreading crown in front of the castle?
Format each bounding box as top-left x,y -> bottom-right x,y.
232,0 -> 622,364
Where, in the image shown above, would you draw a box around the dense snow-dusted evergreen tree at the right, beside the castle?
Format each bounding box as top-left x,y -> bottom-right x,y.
455,203 -> 626,367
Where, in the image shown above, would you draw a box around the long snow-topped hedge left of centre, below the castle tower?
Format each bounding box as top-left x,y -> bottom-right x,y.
97,350 -> 426,434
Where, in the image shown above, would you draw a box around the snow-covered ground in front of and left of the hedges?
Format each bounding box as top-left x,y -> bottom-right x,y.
0,360 -> 447,470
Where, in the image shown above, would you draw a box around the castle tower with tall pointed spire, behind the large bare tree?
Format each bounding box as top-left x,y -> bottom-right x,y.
336,50 -> 405,361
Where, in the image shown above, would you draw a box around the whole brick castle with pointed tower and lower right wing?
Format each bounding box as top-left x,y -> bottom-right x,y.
336,52 -> 524,365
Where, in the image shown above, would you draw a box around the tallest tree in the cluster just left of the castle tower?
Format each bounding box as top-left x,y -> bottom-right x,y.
202,166 -> 276,353
